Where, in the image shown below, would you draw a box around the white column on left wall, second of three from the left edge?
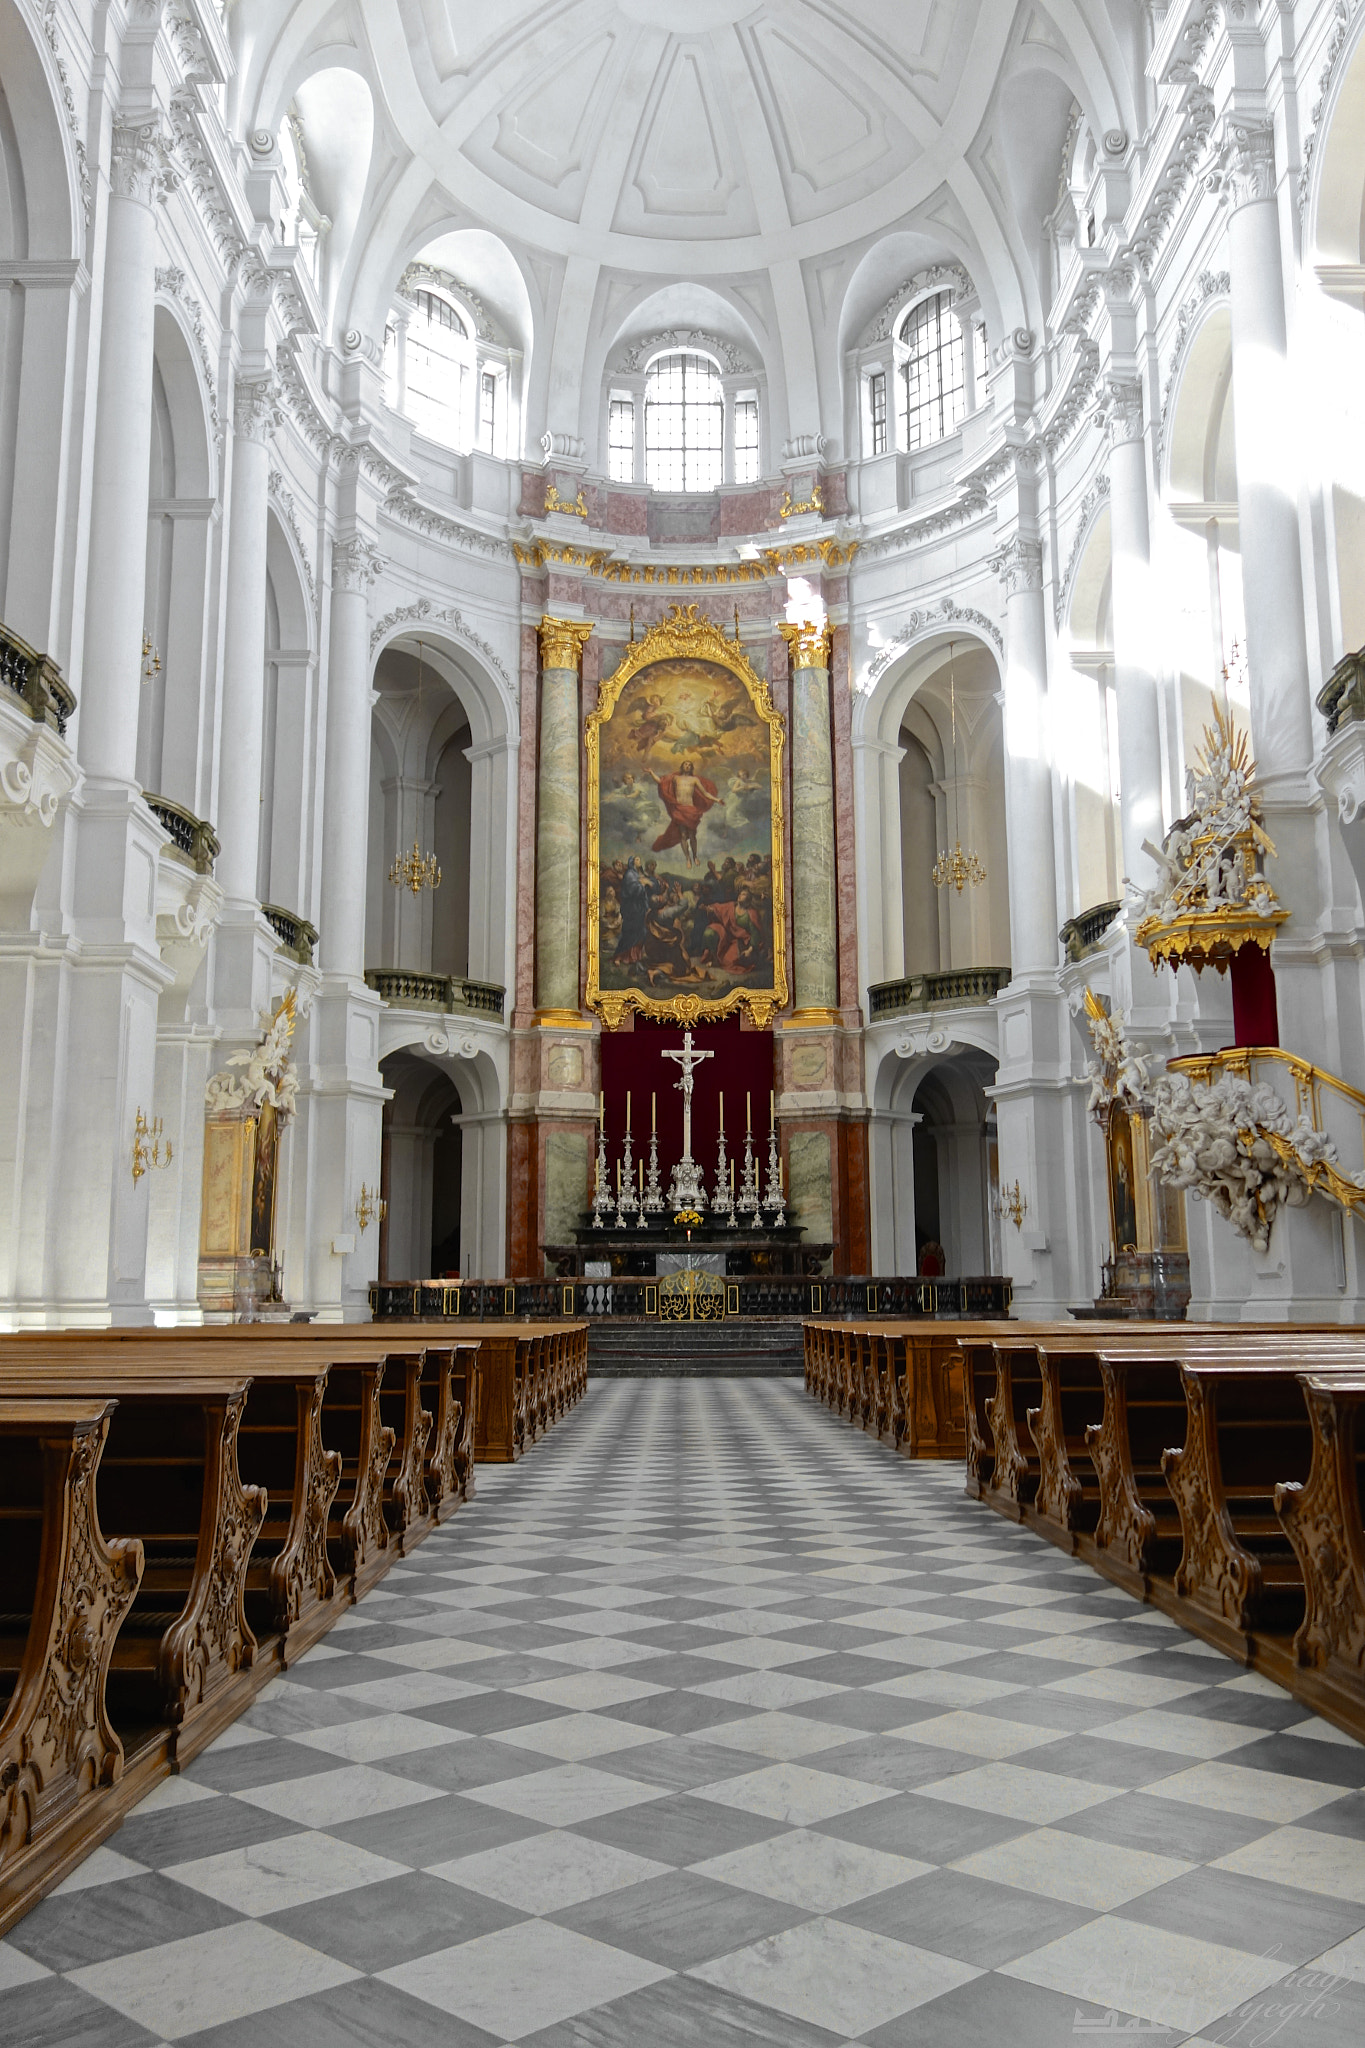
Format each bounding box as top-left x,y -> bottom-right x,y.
215,375 -> 282,903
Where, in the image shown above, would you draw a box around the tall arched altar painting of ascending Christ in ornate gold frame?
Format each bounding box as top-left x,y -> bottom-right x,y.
585,606 -> 786,1028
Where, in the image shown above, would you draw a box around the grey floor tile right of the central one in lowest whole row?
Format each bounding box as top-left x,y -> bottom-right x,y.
837,1870 -> 1095,1970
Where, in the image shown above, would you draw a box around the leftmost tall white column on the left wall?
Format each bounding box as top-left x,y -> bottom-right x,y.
78,119 -> 176,782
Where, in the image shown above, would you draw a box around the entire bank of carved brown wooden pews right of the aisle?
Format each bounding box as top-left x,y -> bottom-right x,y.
804,1319 -> 1365,1741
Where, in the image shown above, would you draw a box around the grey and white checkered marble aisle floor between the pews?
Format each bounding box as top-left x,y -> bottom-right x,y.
0,1380 -> 1365,2048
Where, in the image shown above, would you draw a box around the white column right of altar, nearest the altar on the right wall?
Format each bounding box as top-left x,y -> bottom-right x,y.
990,535 -> 1058,977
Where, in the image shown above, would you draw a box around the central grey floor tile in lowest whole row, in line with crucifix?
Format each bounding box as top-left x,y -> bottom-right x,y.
553,1870 -> 808,1970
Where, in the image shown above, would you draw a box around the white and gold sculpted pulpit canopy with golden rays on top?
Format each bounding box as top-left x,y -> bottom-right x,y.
1130,705 -> 1289,973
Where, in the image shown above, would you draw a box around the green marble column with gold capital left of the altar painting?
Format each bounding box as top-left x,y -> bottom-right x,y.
536,616 -> 591,1024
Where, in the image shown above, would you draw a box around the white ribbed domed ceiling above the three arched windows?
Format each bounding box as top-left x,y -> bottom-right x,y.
384,0 -> 1013,270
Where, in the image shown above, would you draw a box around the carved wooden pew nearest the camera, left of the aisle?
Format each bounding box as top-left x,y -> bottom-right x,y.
0,1395 -> 145,1933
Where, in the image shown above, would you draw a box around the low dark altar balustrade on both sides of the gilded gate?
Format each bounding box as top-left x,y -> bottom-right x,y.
370,1274 -> 1011,1323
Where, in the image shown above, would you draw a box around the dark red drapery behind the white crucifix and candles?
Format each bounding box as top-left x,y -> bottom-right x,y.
602,1018 -> 774,1194
